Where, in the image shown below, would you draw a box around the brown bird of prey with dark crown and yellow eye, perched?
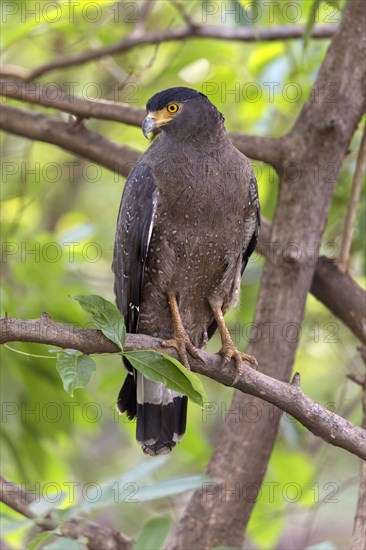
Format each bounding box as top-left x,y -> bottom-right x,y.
113,87 -> 259,455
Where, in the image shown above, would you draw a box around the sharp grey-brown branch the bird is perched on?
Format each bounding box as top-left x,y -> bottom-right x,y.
0,315 -> 366,459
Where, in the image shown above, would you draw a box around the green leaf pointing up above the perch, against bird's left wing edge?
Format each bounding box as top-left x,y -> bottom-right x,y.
73,294 -> 126,350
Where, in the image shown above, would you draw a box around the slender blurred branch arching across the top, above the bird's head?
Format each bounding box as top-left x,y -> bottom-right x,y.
4,24 -> 337,81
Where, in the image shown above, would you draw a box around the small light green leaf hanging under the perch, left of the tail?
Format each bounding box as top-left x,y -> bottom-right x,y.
56,353 -> 96,397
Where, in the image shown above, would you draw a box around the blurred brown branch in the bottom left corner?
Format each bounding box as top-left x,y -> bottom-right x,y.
0,476 -> 133,550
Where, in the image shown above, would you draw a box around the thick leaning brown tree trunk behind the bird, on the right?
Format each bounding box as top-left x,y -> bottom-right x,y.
168,0 -> 366,550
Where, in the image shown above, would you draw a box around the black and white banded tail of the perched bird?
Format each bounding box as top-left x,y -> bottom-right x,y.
117,371 -> 188,456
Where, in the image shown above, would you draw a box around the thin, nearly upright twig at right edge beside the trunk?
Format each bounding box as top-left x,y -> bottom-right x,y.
339,127 -> 366,272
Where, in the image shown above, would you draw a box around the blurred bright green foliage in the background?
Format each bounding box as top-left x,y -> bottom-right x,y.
0,0 -> 366,549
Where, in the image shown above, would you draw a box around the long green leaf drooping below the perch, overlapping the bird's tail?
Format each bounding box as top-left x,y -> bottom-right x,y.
123,350 -> 207,407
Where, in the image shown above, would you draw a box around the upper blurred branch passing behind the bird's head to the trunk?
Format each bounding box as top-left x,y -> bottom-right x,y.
0,79 -> 285,167
